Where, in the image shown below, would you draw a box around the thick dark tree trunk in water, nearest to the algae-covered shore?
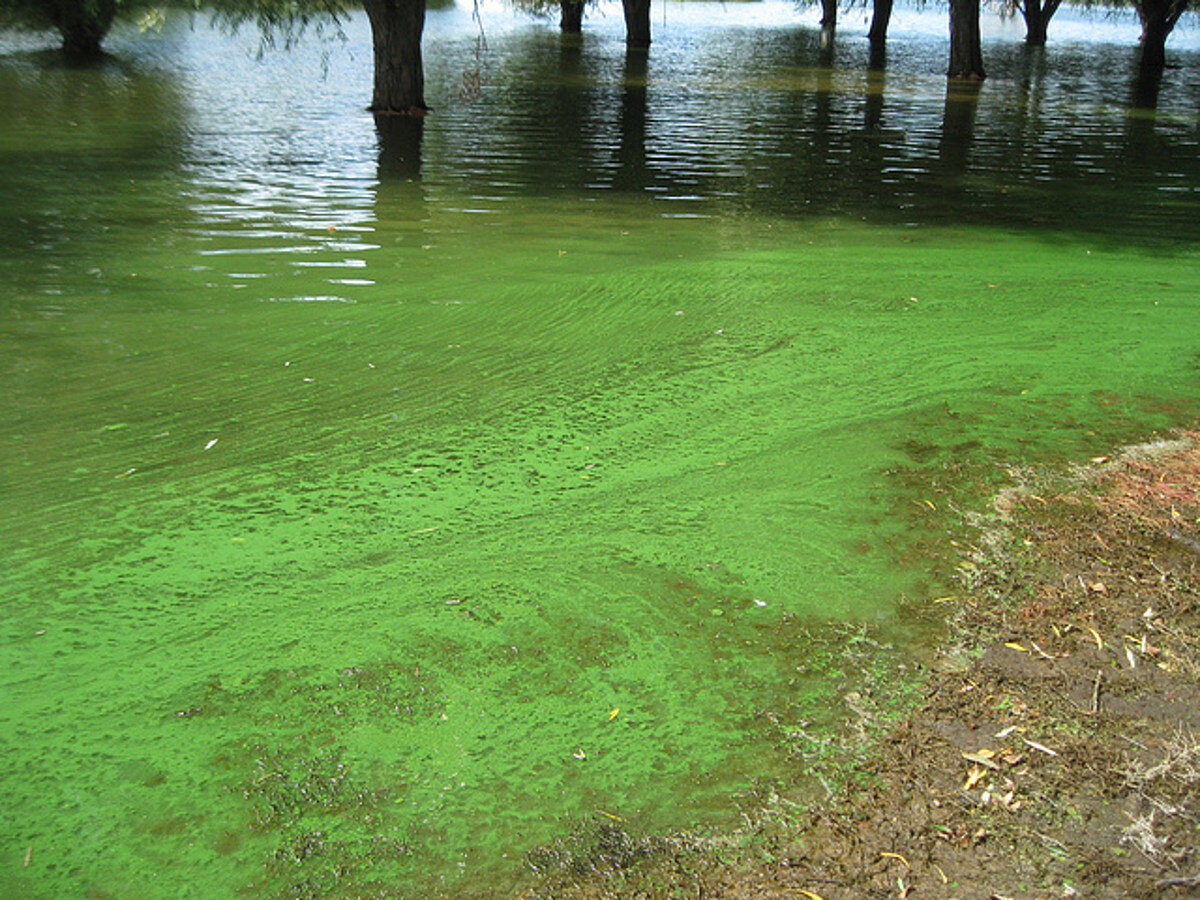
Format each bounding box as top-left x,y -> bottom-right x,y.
362,0 -> 428,116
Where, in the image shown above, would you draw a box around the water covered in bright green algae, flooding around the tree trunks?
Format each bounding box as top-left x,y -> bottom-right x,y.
0,2 -> 1200,899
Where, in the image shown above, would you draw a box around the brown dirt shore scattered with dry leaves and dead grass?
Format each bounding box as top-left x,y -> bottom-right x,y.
524,432 -> 1200,900
